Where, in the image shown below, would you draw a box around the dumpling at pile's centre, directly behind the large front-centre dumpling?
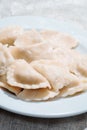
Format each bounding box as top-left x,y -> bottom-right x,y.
26,43 -> 56,61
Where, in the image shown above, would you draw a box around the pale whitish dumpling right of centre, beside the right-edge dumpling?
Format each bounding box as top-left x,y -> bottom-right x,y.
55,47 -> 80,68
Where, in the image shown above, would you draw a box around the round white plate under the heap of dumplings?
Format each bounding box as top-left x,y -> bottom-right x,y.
0,16 -> 87,118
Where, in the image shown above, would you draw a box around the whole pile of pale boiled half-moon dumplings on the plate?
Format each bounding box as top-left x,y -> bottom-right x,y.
0,26 -> 87,101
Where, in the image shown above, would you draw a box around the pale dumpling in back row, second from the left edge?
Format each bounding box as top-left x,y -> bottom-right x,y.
14,30 -> 43,48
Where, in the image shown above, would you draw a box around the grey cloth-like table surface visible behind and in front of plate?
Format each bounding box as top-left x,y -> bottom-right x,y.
0,0 -> 87,130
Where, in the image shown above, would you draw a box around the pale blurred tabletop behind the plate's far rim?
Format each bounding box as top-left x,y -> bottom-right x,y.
0,0 -> 87,29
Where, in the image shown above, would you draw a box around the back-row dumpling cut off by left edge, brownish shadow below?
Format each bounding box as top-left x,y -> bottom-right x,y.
0,26 -> 23,45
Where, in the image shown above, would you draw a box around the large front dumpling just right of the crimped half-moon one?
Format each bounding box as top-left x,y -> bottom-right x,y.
31,60 -> 77,91
